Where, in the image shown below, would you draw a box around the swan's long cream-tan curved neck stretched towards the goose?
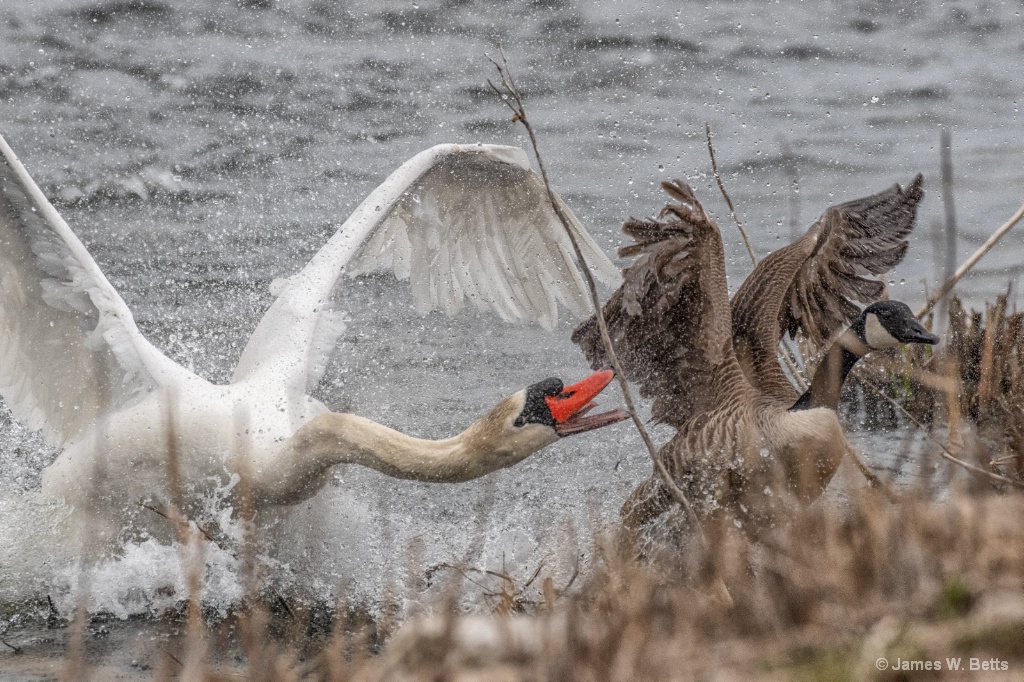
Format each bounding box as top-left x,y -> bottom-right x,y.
250,396 -> 544,504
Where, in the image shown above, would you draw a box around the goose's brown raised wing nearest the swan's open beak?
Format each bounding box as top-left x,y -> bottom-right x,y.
572,180 -> 750,428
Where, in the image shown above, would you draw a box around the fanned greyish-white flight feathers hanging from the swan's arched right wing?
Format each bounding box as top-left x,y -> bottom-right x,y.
348,146 -> 618,328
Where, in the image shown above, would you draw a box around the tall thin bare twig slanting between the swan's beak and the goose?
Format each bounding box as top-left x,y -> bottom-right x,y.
487,50 -> 708,549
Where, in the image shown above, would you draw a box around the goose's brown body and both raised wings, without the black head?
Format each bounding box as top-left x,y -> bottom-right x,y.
572,176 -> 923,529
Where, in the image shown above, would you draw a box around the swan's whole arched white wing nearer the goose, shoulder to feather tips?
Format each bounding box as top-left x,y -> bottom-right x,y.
234,144 -> 618,392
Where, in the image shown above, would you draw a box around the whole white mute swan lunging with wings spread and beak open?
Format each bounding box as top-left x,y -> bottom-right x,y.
0,131 -> 625,534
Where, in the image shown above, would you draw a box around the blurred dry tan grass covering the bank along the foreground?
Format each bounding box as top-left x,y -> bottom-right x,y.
25,487 -> 1024,682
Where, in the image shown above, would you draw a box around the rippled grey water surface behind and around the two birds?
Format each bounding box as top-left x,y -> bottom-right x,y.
0,0 -> 1024,638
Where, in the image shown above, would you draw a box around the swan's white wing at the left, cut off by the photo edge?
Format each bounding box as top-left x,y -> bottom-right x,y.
0,137 -> 185,445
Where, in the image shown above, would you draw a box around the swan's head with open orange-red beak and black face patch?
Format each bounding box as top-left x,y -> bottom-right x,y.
467,370 -> 629,469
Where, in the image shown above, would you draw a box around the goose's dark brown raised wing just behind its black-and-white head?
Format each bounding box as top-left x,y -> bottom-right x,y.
732,174 -> 924,399
